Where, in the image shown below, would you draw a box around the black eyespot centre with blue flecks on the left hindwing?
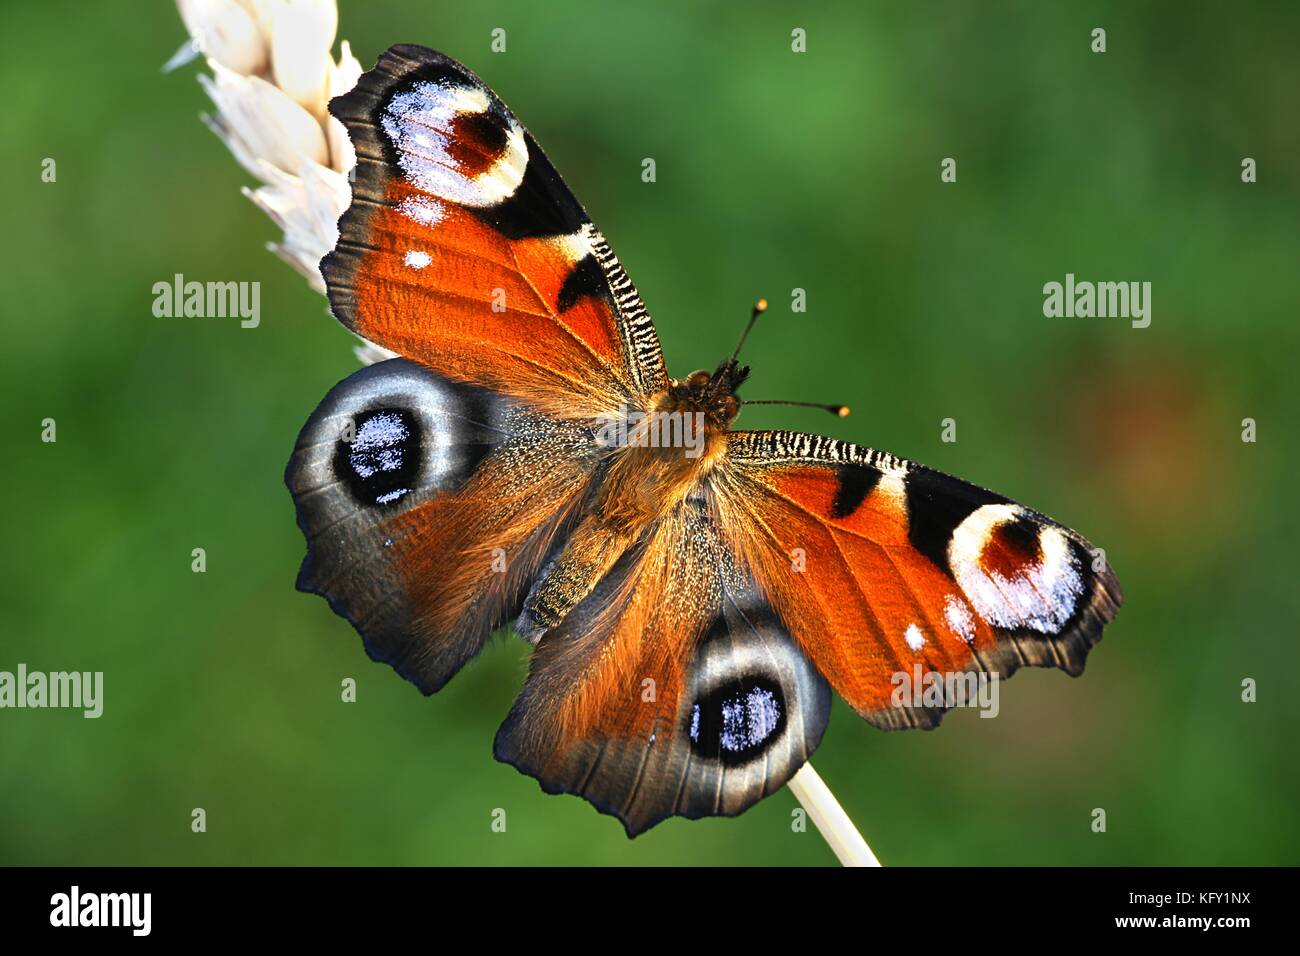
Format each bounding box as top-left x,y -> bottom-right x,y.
334,408 -> 421,505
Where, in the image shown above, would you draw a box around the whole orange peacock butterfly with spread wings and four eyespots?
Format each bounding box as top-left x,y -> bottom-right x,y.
286,47 -> 1121,835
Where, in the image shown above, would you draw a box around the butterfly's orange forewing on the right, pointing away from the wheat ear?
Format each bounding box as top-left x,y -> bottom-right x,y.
715,432 -> 1122,728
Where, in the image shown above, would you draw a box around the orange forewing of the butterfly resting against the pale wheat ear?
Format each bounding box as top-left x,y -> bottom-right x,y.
321,46 -> 667,418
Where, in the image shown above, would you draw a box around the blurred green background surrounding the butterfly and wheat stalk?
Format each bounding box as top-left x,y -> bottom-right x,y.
0,0 -> 1300,864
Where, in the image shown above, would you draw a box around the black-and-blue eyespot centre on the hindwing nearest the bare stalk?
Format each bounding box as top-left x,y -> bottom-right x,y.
688,678 -> 785,763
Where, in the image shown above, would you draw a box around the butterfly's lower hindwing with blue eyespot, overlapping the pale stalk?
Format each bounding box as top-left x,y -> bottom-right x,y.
495,502 -> 831,835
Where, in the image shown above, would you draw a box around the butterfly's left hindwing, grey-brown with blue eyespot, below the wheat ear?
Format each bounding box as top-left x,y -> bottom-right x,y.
286,359 -> 595,693
